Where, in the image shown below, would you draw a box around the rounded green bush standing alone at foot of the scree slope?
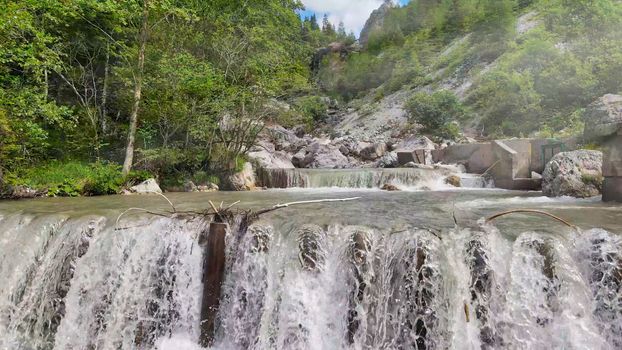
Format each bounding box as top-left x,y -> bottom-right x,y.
406,90 -> 466,139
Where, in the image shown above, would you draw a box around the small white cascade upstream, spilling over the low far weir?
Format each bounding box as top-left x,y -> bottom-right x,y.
259,166 -> 492,190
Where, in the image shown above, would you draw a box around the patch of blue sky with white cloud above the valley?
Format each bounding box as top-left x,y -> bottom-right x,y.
301,0 -> 409,37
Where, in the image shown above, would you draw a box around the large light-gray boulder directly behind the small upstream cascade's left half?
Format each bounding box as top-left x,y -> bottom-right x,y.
292,142 -> 351,169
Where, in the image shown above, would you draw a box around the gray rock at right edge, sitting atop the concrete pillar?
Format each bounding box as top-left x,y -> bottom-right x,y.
583,94 -> 622,140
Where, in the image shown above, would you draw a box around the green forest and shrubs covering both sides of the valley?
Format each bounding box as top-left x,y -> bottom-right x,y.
0,0 -> 622,195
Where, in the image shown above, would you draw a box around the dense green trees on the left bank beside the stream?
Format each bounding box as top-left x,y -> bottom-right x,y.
0,0 -> 347,194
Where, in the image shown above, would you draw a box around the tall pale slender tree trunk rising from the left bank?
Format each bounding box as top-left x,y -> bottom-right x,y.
123,0 -> 149,175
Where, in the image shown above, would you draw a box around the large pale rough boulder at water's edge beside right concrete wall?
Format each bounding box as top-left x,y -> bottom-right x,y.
542,150 -> 603,198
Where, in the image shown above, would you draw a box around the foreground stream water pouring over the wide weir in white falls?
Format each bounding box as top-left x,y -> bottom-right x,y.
0,188 -> 622,350
